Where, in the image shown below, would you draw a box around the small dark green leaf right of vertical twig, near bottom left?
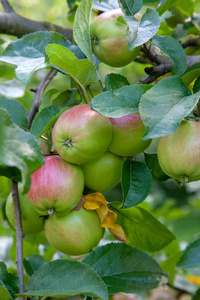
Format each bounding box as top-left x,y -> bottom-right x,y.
24,254 -> 46,276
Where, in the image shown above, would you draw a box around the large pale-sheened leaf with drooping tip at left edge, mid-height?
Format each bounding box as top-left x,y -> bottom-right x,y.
0,109 -> 44,193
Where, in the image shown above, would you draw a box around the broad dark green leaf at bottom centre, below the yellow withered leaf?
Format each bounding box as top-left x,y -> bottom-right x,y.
83,243 -> 168,294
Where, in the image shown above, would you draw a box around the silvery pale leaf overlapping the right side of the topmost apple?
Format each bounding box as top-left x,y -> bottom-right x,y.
126,8 -> 160,51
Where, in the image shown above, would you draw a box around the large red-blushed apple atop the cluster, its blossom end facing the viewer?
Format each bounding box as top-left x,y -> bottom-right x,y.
52,104 -> 112,165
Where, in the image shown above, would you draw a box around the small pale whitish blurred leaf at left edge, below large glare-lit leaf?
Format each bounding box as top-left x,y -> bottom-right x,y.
0,78 -> 25,98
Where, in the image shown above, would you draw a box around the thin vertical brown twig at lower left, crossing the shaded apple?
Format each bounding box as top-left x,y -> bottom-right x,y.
11,179 -> 24,300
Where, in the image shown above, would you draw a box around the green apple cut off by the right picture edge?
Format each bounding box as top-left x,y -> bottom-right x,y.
157,120 -> 200,183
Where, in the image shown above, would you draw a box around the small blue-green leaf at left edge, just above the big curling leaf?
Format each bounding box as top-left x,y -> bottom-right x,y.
0,97 -> 28,128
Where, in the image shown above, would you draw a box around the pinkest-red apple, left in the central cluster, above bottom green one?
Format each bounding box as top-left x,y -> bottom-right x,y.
27,156 -> 84,216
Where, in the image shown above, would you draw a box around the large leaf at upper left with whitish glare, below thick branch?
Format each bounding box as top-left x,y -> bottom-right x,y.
0,31 -> 83,86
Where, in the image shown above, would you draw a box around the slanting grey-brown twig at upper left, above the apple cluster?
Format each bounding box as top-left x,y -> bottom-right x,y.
27,69 -> 57,129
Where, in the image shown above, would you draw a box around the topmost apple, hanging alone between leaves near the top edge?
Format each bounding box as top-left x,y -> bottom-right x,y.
90,9 -> 141,67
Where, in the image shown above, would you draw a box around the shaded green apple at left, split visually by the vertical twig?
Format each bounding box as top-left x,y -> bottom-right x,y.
5,185 -> 44,234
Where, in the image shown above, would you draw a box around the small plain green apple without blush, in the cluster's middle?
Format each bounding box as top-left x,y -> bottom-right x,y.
81,152 -> 124,192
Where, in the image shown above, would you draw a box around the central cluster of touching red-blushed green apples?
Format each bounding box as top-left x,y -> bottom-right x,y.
7,104 -> 151,255
